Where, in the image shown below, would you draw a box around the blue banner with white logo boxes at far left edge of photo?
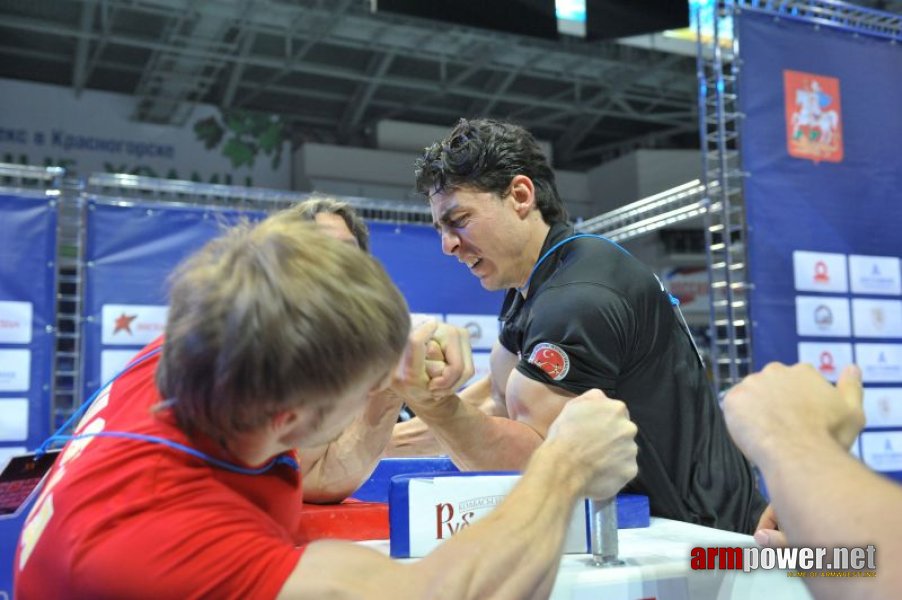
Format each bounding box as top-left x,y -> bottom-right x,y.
0,194 -> 57,454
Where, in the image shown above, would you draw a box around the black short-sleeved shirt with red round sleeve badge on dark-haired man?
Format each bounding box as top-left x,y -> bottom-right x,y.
500,223 -> 766,533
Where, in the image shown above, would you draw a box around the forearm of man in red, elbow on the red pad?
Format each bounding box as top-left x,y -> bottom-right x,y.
301,393 -> 401,504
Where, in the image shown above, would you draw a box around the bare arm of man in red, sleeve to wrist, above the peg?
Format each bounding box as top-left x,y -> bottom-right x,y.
280,446 -> 584,600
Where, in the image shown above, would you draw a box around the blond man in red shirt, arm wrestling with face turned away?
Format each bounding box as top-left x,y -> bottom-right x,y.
14,213 -> 636,600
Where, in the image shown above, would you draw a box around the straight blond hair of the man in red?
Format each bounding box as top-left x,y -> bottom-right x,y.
156,211 -> 410,439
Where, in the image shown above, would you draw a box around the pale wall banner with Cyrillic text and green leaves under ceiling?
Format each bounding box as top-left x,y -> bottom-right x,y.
0,79 -> 291,190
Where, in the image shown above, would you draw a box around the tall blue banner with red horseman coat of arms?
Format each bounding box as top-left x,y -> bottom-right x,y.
737,11 -> 902,480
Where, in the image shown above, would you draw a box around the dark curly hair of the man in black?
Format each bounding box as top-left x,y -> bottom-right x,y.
415,119 -> 568,225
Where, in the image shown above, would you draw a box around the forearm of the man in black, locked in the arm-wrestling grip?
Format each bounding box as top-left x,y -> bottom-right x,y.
417,396 -> 543,471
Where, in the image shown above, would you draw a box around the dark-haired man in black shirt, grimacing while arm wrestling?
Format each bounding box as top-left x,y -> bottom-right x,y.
414,120 -> 765,533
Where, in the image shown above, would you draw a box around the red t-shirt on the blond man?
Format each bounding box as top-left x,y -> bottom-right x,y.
14,340 -> 303,600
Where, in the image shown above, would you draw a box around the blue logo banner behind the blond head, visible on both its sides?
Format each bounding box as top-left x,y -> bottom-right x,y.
83,199 -> 502,398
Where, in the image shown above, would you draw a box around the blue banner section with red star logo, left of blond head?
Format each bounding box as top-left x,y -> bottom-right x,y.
82,199 -> 263,398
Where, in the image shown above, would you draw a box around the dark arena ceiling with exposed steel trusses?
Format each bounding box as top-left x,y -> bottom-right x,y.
0,0 -> 902,170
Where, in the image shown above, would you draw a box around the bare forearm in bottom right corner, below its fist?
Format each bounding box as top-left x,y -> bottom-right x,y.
760,439 -> 902,598
